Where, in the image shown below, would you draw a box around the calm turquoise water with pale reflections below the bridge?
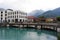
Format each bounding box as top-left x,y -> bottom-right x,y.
0,28 -> 57,40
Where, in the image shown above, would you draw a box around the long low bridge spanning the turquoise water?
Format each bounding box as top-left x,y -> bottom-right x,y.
0,23 -> 60,32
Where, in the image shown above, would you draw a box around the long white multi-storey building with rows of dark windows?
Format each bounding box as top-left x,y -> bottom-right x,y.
0,9 -> 27,23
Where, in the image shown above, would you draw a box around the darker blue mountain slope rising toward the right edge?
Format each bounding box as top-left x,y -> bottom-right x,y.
40,8 -> 60,18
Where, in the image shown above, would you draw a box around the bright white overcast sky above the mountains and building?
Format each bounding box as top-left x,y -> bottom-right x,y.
0,0 -> 60,13
